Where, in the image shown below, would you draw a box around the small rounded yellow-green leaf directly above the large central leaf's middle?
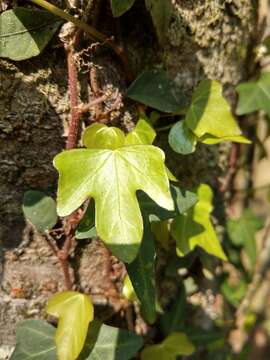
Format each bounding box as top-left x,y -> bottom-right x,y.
82,123 -> 125,150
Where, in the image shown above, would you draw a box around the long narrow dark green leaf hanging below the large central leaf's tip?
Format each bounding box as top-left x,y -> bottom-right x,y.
126,215 -> 156,324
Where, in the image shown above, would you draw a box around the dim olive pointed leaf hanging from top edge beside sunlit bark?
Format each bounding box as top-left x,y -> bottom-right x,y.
145,0 -> 172,43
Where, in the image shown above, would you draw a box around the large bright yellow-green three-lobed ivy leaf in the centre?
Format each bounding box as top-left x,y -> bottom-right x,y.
54,125 -> 173,263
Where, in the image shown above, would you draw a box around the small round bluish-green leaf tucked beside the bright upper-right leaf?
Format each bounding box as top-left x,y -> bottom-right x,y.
168,121 -> 197,155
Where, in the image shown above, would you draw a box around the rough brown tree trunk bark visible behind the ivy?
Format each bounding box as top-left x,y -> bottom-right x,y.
0,0 -> 256,359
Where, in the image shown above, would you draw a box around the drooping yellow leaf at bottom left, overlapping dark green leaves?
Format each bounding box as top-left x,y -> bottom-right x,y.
46,291 -> 94,360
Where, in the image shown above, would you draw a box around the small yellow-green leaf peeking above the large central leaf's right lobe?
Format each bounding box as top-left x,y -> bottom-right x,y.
125,118 -> 156,145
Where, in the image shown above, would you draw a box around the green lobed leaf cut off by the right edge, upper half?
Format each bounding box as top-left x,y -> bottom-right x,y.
236,72 -> 270,116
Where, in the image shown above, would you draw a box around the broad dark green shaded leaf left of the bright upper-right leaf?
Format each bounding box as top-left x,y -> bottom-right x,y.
127,70 -> 186,113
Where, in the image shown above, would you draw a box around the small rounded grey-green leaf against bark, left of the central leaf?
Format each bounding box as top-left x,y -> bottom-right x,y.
22,190 -> 57,232
